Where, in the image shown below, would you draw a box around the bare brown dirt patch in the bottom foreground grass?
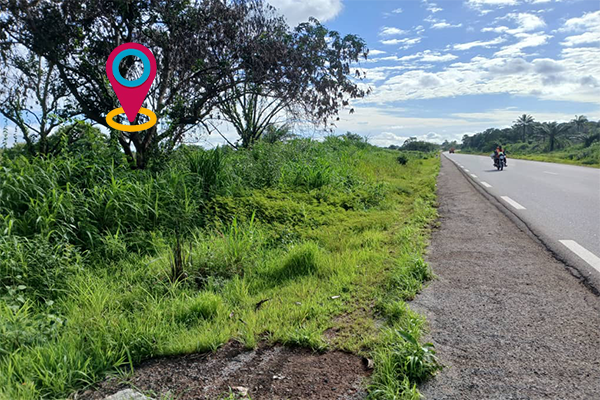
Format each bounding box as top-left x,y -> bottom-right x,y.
77,343 -> 369,400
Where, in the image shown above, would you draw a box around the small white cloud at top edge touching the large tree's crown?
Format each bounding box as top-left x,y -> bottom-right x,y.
268,0 -> 343,26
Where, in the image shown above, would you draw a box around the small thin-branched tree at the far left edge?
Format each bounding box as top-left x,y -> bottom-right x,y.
0,48 -> 73,156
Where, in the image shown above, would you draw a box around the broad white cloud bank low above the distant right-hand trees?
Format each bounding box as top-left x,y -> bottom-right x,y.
362,47 -> 600,105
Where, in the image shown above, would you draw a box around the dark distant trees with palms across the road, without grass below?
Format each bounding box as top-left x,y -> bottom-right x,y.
462,114 -> 600,153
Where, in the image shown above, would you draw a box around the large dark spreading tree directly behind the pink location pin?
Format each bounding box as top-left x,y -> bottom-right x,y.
0,0 -> 328,168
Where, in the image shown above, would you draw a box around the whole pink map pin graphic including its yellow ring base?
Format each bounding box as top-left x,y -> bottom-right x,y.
106,43 -> 157,132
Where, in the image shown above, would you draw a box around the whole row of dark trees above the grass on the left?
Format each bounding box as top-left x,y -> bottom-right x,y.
0,0 -> 370,169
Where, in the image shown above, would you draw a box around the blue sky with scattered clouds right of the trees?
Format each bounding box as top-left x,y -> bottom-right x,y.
271,0 -> 600,146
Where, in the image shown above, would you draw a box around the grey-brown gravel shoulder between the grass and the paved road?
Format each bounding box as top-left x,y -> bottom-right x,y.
411,157 -> 600,400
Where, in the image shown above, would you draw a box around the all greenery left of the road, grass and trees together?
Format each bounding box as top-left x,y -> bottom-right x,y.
0,0 -> 440,400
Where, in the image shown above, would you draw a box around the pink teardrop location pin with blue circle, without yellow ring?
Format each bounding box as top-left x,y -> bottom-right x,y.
106,43 -> 156,122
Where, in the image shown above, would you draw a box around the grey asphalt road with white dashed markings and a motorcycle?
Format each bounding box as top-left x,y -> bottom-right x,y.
444,153 -> 600,290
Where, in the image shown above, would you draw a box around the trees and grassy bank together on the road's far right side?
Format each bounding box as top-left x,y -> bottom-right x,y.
460,115 -> 600,168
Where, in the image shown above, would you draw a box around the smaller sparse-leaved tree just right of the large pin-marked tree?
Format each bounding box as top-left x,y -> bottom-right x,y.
211,18 -> 370,147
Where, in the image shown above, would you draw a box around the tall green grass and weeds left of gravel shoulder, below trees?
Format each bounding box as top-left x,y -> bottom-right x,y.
0,138 -> 439,399
